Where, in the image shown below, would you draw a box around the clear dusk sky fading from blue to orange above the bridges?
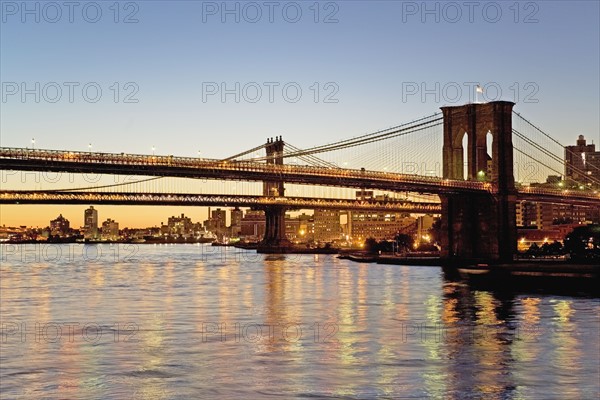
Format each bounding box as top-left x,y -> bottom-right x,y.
0,1 -> 600,226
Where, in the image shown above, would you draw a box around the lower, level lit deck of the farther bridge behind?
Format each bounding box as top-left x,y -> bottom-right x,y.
0,190 -> 442,214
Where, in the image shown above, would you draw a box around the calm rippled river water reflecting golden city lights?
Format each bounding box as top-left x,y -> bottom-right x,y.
0,244 -> 600,399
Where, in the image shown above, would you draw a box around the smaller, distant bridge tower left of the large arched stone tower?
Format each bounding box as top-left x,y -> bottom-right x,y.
258,136 -> 292,253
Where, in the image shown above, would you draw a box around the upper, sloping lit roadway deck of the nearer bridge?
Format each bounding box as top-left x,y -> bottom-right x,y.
0,147 -> 600,205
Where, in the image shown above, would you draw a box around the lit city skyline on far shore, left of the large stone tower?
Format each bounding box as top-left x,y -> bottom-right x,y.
0,206 -> 439,247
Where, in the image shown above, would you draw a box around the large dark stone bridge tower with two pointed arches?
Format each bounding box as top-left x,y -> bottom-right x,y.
440,101 -> 517,262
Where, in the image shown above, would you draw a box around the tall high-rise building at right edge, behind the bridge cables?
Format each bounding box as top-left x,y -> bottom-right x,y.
565,135 -> 600,187
